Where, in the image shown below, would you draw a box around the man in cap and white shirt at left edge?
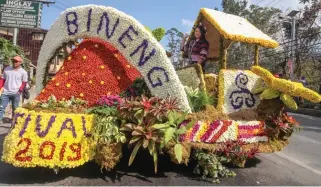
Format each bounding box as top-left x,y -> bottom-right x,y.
0,56 -> 28,124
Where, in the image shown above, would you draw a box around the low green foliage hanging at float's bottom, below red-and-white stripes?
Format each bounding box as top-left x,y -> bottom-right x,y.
193,150 -> 236,183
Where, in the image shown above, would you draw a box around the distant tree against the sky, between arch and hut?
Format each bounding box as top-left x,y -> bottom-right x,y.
165,28 -> 184,65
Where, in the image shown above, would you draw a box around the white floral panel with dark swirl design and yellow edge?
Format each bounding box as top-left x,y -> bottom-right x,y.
218,70 -> 260,114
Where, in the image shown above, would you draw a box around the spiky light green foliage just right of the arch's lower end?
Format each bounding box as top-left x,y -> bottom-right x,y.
185,87 -> 215,112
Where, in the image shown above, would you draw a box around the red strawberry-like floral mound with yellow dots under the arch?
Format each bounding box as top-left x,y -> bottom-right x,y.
36,38 -> 140,106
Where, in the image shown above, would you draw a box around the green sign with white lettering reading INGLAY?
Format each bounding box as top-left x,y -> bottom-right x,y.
0,0 -> 42,28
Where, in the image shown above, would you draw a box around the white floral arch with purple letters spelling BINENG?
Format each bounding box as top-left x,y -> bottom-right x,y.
36,5 -> 191,112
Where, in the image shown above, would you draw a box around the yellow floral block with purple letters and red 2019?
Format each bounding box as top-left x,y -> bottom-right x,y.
2,108 -> 96,168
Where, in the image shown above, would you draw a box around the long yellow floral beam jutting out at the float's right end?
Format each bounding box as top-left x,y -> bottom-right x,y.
251,66 -> 321,103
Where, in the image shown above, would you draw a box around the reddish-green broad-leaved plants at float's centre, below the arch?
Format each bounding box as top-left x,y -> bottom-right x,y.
118,96 -> 179,173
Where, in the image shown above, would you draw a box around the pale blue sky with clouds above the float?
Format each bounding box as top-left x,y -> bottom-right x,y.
42,0 -> 299,47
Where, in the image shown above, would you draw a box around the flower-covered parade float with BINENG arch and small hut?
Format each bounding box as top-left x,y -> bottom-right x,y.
2,5 -> 321,182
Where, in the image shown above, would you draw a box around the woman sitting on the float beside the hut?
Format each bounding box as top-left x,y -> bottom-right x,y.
181,24 -> 209,71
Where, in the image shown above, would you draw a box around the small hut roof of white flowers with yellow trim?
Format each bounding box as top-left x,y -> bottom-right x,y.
191,8 -> 279,58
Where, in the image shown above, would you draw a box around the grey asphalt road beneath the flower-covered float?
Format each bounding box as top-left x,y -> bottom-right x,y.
0,114 -> 321,186
